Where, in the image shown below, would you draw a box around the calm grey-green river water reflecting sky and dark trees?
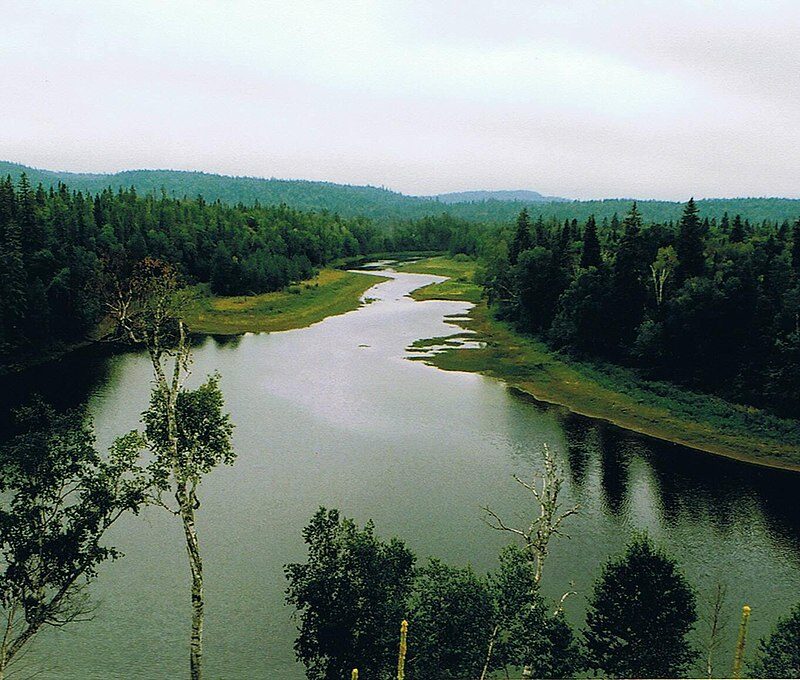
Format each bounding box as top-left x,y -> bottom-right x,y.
0,274 -> 800,680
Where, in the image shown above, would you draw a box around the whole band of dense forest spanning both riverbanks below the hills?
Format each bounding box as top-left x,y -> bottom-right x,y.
0,168 -> 800,417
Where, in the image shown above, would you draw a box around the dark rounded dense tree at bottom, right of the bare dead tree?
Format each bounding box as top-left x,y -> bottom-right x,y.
584,536 -> 697,678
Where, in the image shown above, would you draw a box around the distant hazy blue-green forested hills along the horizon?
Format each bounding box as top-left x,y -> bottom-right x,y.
0,161 -> 800,225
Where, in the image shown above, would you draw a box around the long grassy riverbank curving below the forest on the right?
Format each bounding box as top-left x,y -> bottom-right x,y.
400,257 -> 800,470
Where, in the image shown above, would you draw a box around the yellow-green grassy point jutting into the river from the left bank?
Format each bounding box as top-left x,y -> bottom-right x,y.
186,269 -> 387,335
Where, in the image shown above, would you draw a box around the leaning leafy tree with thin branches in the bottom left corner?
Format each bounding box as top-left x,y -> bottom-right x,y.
0,401 -> 149,680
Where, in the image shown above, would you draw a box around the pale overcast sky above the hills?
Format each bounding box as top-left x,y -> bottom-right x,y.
0,0 -> 800,199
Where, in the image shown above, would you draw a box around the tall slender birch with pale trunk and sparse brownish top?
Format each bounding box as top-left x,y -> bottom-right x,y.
105,259 -> 236,680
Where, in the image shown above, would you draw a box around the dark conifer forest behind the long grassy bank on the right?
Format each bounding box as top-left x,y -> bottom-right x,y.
483,200 -> 800,417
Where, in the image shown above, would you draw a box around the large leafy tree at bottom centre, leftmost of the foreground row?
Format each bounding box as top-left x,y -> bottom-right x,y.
285,508 -> 415,680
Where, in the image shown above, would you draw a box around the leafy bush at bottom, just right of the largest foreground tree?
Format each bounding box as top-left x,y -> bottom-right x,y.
407,559 -> 495,680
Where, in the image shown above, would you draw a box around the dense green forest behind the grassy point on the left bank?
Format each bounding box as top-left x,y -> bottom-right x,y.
0,175 -> 477,364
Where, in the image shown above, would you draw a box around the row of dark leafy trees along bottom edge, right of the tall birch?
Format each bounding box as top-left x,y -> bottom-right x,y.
286,508 -> 800,680
